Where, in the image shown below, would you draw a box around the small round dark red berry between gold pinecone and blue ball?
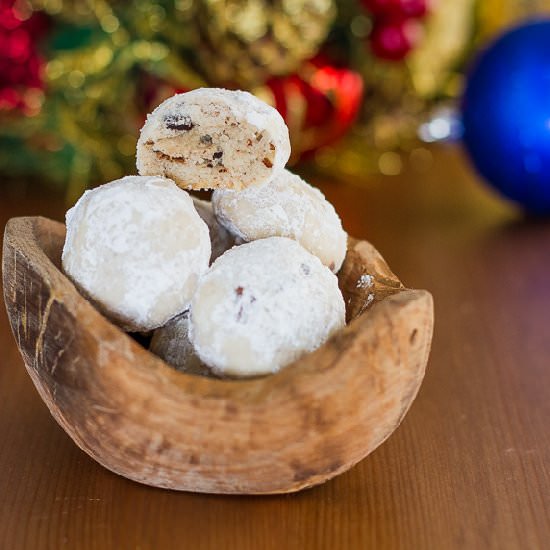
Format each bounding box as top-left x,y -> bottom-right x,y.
370,19 -> 422,61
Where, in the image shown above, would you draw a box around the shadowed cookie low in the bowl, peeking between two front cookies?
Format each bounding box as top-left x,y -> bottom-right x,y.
149,311 -> 211,376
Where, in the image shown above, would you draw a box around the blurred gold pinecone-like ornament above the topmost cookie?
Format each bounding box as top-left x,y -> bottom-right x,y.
193,0 -> 335,88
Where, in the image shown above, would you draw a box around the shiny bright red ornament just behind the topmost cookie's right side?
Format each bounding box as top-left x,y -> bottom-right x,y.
266,57 -> 363,161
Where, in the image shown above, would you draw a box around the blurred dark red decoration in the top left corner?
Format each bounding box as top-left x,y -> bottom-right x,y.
0,0 -> 48,114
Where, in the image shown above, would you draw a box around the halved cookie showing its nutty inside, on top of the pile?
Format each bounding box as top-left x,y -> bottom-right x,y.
137,88 -> 290,193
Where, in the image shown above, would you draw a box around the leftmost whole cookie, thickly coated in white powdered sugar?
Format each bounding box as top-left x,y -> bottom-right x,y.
62,176 -> 210,331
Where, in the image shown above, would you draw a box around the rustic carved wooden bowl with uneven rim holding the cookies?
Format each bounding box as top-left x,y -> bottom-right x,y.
3,218 -> 433,494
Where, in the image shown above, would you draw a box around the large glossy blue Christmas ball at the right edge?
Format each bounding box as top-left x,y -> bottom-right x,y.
462,20 -> 550,214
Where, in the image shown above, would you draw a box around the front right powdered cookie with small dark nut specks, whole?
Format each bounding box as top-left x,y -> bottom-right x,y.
189,237 -> 345,376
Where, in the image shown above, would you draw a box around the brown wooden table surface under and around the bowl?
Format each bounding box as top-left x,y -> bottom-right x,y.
0,149 -> 550,550
